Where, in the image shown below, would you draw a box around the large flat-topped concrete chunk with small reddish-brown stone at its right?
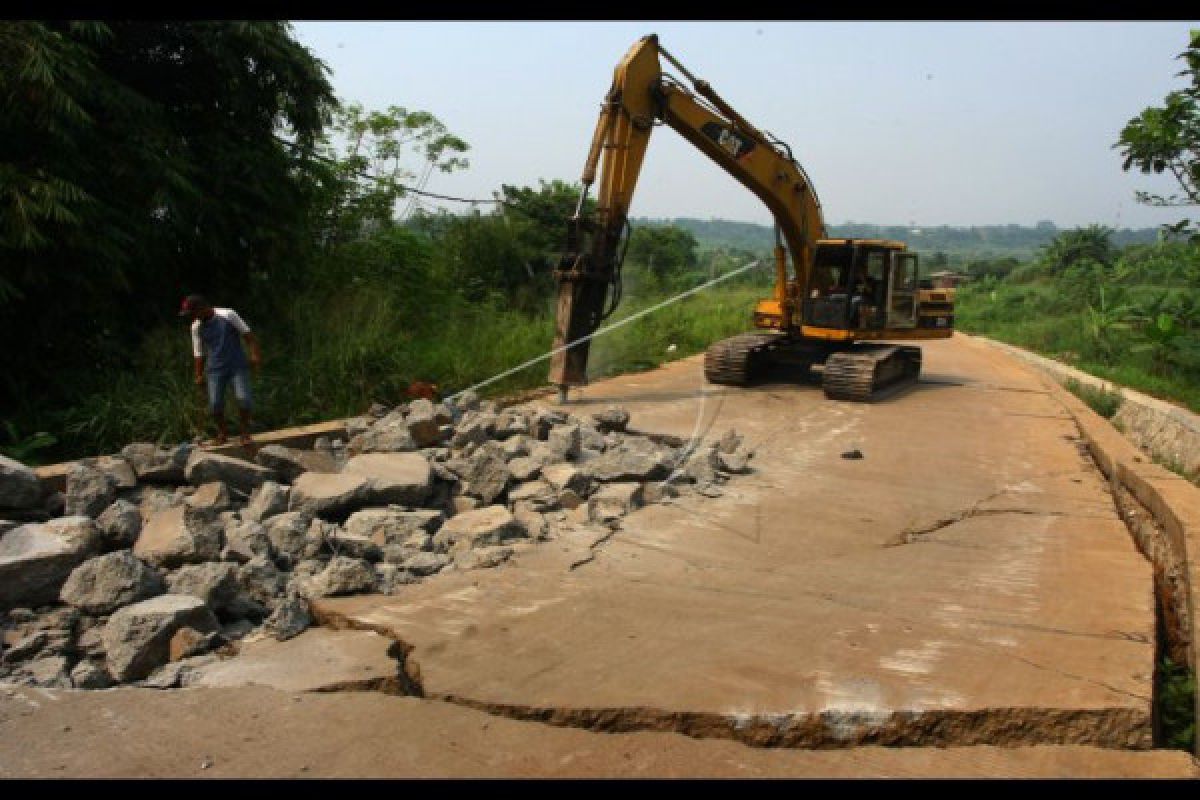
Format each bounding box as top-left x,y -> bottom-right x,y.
104,595 -> 217,682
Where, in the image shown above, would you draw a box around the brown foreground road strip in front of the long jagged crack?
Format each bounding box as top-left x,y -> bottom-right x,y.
0,688 -> 1198,778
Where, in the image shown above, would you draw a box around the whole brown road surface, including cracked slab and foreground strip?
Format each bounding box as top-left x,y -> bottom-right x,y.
0,337 -> 1196,777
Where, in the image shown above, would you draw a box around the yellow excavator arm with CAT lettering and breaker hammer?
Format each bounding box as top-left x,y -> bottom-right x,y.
550,35 -> 826,397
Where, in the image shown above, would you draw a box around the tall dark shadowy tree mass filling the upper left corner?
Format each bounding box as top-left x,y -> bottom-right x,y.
0,20 -> 335,415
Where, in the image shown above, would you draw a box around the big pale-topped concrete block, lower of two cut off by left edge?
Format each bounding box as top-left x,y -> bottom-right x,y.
0,517 -> 101,610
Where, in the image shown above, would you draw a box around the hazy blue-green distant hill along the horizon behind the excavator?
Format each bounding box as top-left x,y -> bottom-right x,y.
631,217 -> 1158,260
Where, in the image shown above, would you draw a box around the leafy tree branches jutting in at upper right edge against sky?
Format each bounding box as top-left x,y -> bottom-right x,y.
1114,30 -> 1200,241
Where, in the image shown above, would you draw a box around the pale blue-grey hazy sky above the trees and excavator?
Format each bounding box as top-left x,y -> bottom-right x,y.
294,22 -> 1200,228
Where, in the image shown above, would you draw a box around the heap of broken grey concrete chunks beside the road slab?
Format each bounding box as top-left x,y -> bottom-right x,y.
0,392 -> 752,688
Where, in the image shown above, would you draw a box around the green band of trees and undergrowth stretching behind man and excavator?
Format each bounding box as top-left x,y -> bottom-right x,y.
0,20 -> 1200,463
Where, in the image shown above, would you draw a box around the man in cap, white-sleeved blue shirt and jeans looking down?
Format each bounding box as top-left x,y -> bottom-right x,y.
179,294 -> 263,446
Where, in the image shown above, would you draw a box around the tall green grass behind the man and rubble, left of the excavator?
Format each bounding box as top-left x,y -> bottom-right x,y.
13,285 -> 769,463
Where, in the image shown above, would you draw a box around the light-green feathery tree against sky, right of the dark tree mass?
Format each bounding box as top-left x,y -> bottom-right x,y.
317,103 -> 470,245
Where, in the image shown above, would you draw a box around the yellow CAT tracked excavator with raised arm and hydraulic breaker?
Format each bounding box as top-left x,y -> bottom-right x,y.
550,35 -> 954,401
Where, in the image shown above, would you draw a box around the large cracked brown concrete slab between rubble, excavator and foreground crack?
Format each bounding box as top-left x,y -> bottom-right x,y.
319,337 -> 1154,748
